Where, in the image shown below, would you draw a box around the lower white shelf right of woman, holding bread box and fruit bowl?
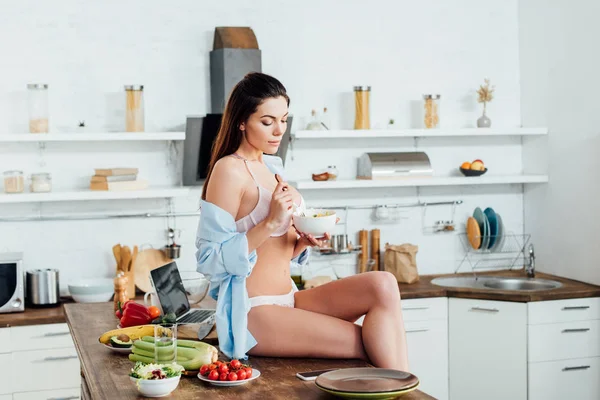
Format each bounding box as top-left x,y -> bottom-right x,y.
290,175 -> 548,190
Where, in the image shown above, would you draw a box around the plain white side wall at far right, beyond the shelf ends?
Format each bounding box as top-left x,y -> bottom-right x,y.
519,0 -> 600,284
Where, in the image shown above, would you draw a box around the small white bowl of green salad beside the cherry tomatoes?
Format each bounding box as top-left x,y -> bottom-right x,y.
129,361 -> 183,397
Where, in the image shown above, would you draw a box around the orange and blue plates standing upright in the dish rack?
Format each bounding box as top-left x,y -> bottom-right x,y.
467,207 -> 505,252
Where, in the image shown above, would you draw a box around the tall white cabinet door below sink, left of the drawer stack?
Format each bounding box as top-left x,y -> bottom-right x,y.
448,299 -> 527,400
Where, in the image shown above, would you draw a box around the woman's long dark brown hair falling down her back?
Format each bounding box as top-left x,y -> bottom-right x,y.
202,72 -> 290,200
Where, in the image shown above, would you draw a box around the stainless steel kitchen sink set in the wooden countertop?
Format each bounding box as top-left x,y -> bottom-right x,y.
431,276 -> 562,292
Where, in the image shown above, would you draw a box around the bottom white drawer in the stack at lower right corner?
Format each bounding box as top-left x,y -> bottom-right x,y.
529,358 -> 600,400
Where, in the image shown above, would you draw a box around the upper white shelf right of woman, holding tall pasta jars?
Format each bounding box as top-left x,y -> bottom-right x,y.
293,128 -> 548,139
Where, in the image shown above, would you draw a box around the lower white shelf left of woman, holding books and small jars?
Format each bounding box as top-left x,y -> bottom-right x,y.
0,187 -> 190,203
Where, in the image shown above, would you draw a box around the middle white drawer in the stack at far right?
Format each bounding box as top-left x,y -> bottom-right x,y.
528,320 -> 600,362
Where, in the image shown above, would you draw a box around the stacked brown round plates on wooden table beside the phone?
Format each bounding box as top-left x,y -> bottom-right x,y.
315,368 -> 419,400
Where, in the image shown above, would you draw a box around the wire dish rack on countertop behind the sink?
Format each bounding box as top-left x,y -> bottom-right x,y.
454,233 -> 531,273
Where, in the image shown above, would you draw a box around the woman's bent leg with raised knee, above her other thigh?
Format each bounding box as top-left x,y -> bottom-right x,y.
295,271 -> 408,371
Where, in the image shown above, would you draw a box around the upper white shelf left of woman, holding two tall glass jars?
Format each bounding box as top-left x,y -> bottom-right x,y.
0,132 -> 185,143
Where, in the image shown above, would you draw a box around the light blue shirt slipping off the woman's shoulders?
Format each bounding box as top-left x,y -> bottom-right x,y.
196,156 -> 310,360
